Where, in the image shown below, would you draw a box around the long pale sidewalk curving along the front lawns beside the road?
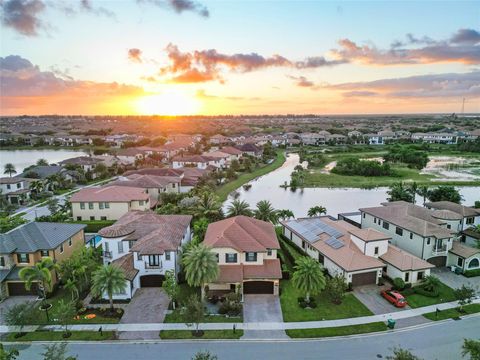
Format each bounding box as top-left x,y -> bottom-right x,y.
0,298 -> 480,333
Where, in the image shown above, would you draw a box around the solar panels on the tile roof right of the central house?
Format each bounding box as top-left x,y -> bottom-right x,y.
288,219 -> 345,249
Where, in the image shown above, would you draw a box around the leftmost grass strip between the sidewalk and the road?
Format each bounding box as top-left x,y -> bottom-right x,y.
3,331 -> 115,341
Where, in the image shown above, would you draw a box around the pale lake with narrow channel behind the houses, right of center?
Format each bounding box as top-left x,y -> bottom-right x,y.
225,154 -> 480,217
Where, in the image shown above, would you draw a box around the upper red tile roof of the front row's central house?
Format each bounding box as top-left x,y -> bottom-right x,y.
203,215 -> 280,252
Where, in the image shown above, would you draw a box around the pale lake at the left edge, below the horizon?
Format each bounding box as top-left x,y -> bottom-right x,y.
0,149 -> 86,176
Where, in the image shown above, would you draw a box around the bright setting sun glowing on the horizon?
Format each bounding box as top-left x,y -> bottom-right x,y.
136,91 -> 201,115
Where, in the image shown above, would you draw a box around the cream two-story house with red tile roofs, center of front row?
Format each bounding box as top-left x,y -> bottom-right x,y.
203,216 -> 282,295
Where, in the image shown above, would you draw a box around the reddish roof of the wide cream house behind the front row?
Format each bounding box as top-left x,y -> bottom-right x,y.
70,185 -> 149,202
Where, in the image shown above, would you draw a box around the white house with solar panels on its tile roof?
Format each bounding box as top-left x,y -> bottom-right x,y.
282,216 -> 434,286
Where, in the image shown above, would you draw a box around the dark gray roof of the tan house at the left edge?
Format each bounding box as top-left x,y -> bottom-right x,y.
0,222 -> 86,253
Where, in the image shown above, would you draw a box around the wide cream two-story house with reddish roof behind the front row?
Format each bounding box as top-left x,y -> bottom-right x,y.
70,185 -> 152,221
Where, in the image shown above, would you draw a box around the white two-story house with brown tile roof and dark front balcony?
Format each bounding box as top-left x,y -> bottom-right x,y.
99,211 -> 192,299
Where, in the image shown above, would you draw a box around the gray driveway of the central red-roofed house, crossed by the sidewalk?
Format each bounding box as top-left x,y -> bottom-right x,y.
242,295 -> 288,339
